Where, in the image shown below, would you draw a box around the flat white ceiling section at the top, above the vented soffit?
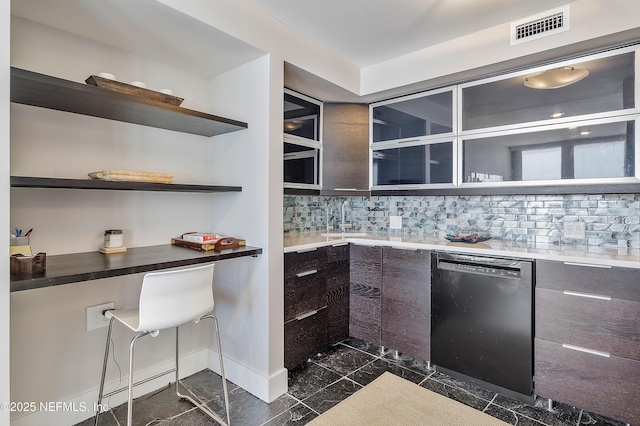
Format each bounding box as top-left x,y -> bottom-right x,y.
247,0 -> 574,67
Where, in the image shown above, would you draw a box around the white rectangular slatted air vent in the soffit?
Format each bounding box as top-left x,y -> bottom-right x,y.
511,5 -> 569,46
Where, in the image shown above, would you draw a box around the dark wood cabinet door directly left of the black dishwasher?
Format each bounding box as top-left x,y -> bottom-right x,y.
381,247 -> 431,360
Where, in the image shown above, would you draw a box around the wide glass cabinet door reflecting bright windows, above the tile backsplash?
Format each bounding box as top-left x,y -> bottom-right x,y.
461,114 -> 639,185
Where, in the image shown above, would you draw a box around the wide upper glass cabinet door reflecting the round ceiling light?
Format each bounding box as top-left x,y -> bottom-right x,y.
460,51 -> 636,132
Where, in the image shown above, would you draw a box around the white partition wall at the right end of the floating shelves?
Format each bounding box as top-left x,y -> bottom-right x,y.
210,56 -> 287,401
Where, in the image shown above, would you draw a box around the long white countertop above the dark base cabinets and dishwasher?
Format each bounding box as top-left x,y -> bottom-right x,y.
284,232 -> 640,269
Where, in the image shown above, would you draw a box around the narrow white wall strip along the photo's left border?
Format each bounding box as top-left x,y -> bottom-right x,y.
0,2 -> 11,425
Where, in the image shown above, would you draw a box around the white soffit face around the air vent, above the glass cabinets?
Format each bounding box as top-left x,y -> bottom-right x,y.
360,0 -> 640,95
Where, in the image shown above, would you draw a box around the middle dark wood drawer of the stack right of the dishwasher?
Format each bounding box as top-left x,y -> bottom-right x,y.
535,288 -> 640,361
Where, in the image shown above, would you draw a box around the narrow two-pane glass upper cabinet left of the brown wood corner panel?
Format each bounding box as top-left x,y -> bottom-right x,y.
284,89 -> 322,189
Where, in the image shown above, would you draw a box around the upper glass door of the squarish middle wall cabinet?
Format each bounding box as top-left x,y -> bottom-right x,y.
371,89 -> 454,143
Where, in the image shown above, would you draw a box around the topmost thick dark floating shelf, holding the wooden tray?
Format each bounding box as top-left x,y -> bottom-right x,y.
11,67 -> 247,136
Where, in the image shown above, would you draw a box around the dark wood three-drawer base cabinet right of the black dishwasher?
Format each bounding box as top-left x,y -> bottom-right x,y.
534,261 -> 640,424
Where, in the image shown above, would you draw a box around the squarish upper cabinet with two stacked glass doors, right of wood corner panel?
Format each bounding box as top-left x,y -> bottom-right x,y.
370,88 -> 456,189
